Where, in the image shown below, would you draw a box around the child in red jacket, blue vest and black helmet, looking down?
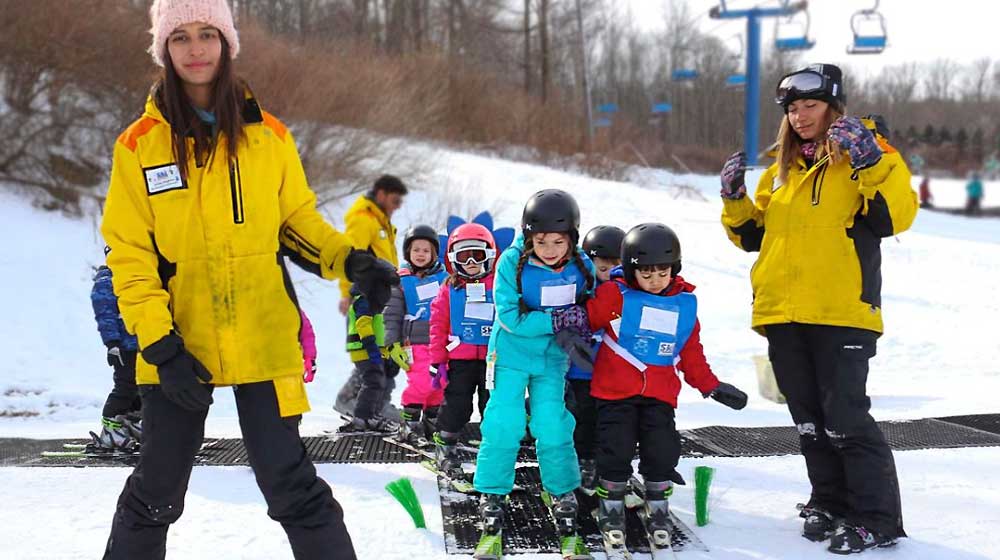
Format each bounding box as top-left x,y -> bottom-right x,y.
587,224 -> 747,546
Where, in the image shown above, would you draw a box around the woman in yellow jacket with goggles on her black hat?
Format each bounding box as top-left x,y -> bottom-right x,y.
722,64 -> 917,554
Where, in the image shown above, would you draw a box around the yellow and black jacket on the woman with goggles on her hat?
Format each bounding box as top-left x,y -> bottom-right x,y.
722,130 -> 918,334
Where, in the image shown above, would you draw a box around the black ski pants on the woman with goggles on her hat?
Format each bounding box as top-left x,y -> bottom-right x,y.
766,323 -> 905,537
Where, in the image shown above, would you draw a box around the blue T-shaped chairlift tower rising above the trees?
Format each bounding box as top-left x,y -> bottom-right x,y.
708,0 -> 808,165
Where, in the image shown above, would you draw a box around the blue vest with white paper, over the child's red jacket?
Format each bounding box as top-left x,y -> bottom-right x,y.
617,282 -> 698,366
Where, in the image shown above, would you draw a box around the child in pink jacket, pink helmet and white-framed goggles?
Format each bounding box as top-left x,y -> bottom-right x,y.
430,223 -> 497,473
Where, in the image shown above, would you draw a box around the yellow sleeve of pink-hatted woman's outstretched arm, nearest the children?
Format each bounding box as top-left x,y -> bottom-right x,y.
278,132 -> 351,280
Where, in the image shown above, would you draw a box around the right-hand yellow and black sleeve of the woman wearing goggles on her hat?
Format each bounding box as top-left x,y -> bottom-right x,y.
858,148 -> 920,237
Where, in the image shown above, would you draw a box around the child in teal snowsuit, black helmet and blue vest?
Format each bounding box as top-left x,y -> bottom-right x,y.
475,189 -> 596,530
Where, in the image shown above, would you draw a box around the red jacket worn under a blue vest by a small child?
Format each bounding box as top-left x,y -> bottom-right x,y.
587,276 -> 719,408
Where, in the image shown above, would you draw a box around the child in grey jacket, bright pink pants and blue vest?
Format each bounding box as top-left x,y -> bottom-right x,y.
383,224 -> 448,445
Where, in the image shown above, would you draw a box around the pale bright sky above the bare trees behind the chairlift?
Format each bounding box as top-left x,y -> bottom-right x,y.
619,0 -> 1000,79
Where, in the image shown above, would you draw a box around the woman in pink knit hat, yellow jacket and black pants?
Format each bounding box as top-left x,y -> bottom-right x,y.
101,0 -> 398,560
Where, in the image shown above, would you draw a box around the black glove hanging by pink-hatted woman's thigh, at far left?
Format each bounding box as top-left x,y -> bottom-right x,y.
142,333 -> 212,411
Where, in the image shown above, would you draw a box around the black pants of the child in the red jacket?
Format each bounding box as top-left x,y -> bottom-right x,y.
595,396 -> 684,484
